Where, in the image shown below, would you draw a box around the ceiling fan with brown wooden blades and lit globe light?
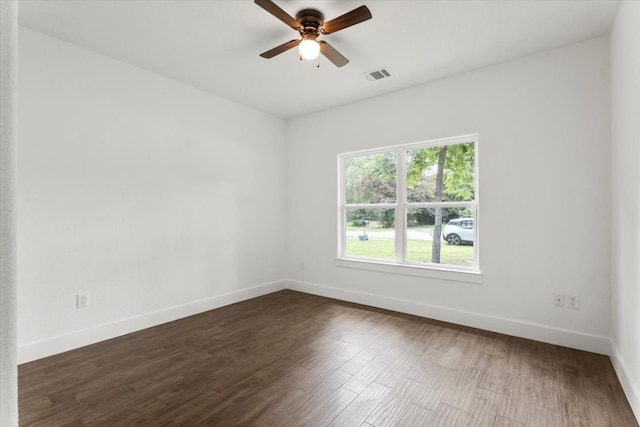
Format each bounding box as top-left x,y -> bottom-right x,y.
254,0 -> 371,67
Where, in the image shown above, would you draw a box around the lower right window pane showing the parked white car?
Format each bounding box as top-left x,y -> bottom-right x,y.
407,208 -> 475,267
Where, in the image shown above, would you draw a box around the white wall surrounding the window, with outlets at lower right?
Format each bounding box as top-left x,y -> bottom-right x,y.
287,37 -> 611,353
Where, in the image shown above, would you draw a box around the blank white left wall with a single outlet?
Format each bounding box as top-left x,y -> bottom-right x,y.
18,28 -> 285,362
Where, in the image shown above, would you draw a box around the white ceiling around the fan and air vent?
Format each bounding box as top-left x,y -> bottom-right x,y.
19,0 -> 619,118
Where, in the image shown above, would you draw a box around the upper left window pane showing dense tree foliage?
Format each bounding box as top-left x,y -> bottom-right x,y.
345,153 -> 396,203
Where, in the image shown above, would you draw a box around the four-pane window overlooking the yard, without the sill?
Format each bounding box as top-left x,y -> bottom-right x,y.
338,135 -> 478,272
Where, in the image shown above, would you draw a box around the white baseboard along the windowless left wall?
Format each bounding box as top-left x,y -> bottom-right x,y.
18,281 -> 285,364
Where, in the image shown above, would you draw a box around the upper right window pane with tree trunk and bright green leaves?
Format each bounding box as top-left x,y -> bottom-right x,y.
407,142 -> 475,202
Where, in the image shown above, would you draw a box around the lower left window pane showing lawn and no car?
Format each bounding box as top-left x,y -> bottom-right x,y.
344,209 -> 396,260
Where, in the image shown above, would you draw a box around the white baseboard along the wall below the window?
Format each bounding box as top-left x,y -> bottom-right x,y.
286,280 -> 610,355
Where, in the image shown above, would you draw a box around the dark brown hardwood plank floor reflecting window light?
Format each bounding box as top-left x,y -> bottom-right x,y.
19,291 -> 638,427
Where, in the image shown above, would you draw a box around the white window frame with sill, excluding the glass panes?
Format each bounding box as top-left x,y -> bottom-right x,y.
336,134 -> 482,283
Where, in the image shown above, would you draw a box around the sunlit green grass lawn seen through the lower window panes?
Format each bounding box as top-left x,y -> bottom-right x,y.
347,237 -> 473,266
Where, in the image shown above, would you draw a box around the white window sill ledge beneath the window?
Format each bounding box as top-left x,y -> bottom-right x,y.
336,258 -> 482,285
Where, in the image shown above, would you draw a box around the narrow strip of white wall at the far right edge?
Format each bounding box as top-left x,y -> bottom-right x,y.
611,1 -> 640,419
